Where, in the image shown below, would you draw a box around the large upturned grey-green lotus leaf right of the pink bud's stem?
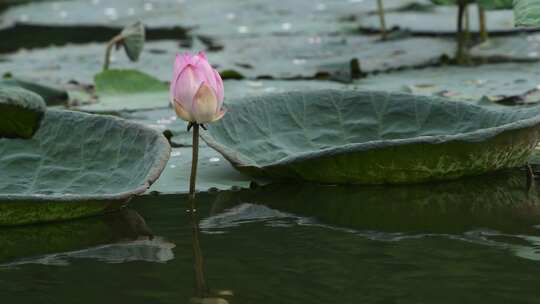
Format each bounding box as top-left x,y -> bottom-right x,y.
203,90 -> 540,184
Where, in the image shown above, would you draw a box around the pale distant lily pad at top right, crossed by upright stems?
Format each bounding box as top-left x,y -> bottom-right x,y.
360,5 -> 519,35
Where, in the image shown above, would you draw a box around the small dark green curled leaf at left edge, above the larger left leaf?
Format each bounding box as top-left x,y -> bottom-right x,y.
0,87 -> 46,140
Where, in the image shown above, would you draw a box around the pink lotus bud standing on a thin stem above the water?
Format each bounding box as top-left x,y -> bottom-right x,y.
170,52 -> 225,124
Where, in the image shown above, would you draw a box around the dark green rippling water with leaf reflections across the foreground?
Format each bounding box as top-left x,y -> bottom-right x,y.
0,171 -> 540,303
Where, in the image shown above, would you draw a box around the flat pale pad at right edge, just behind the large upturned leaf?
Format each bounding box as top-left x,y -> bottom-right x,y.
357,63 -> 540,102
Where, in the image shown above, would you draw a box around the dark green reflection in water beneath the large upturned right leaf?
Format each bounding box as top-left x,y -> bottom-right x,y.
212,169 -> 540,235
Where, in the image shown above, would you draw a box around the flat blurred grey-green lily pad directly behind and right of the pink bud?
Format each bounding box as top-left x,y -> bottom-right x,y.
209,35 -> 455,81
